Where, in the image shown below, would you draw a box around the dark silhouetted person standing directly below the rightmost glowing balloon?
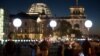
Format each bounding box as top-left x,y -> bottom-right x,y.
82,38 -> 91,56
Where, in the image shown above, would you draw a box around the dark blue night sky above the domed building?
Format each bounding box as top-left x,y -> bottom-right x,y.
0,0 -> 100,34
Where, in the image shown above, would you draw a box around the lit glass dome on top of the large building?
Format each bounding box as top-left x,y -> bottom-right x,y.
27,3 -> 52,16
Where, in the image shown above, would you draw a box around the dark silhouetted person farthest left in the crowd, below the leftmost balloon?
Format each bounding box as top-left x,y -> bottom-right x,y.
4,33 -> 16,56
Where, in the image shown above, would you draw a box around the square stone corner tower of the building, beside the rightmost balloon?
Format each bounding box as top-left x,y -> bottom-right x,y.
67,6 -> 87,34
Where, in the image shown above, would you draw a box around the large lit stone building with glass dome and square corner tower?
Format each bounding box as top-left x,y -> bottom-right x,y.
9,3 -> 87,39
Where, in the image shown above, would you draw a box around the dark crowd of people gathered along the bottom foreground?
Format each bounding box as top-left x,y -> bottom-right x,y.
0,32 -> 100,56
